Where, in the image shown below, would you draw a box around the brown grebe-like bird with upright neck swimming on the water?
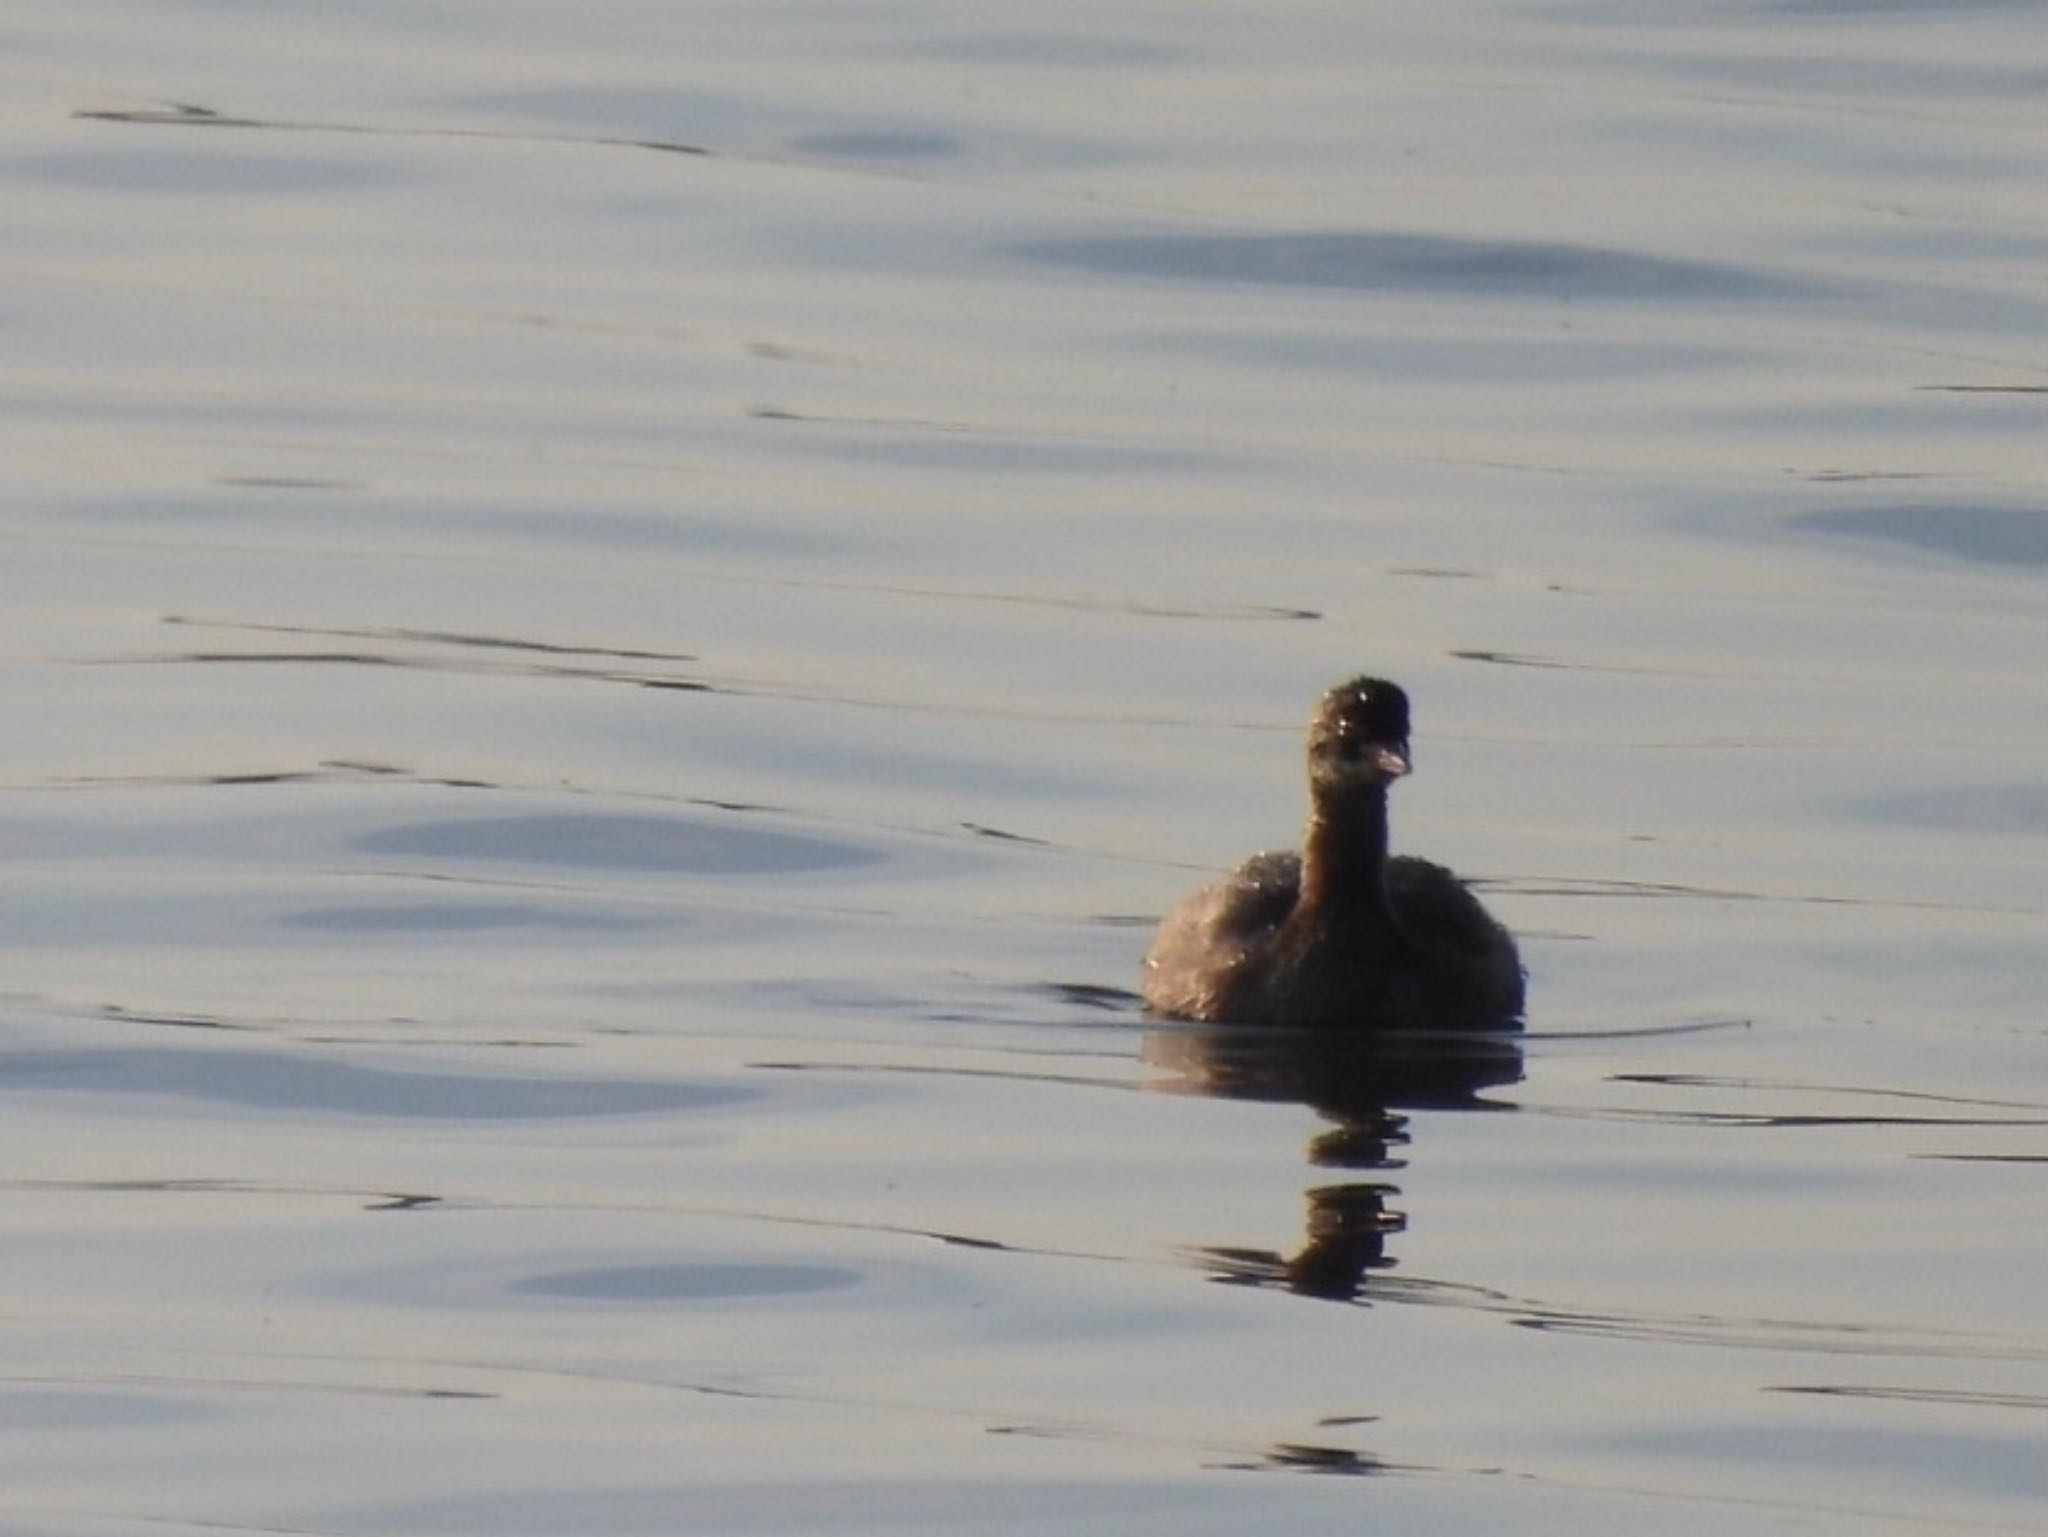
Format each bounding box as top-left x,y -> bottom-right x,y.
1145,678 -> 1524,1031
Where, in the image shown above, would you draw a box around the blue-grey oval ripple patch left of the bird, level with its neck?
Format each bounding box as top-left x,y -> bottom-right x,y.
354,814 -> 883,875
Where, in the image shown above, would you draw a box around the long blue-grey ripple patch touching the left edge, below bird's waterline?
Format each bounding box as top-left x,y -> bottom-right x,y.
0,1049 -> 745,1121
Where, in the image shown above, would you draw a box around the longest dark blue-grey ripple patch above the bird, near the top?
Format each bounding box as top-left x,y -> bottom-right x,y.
1004,230 -> 1815,299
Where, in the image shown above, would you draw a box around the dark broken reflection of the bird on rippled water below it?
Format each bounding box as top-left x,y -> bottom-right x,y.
1143,1025 -> 1522,1301
